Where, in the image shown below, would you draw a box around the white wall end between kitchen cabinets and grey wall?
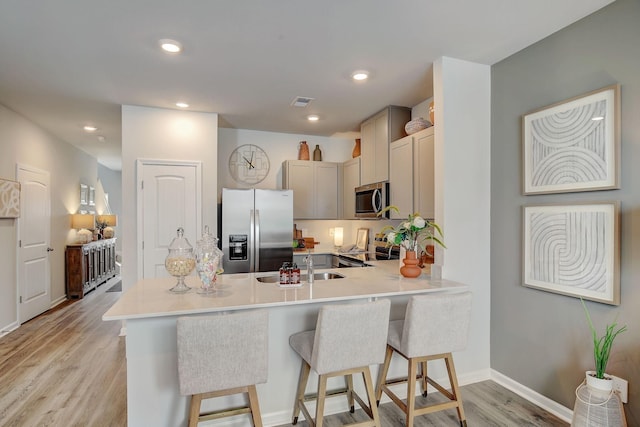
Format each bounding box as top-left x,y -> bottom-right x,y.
434,57 -> 491,372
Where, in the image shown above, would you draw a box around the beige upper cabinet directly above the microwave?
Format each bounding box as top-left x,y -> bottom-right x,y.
360,106 -> 411,185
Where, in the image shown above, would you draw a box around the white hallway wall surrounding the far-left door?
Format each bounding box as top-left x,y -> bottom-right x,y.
0,105 -> 97,335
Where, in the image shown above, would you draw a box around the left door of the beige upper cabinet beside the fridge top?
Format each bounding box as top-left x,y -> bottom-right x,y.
284,160 -> 315,219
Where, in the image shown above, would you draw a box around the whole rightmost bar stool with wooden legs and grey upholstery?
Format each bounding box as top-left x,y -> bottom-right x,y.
376,292 -> 471,427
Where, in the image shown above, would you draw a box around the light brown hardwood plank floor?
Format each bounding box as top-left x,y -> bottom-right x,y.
0,283 -> 567,427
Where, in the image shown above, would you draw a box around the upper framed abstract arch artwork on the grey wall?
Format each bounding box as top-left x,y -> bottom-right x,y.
522,85 -> 620,194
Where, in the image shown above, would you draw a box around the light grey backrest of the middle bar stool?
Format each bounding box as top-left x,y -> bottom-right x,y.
310,299 -> 391,375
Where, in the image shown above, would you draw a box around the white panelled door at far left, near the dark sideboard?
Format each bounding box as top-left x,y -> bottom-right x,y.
16,165 -> 52,323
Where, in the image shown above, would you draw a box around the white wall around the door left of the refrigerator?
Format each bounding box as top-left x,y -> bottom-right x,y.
118,105 -> 218,288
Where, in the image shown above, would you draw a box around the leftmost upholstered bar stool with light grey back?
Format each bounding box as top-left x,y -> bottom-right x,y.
177,310 -> 269,427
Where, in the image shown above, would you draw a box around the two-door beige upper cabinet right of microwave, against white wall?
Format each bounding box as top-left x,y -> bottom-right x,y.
389,127 -> 435,219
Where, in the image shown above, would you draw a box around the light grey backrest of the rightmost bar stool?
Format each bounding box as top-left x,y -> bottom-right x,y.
399,292 -> 471,357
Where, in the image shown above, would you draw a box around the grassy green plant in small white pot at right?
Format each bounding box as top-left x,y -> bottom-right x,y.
580,298 -> 627,391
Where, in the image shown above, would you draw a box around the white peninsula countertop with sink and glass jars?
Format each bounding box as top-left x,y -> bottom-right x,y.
102,260 -> 466,320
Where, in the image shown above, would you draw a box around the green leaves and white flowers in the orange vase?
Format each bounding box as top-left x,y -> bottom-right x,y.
378,205 -> 446,253
